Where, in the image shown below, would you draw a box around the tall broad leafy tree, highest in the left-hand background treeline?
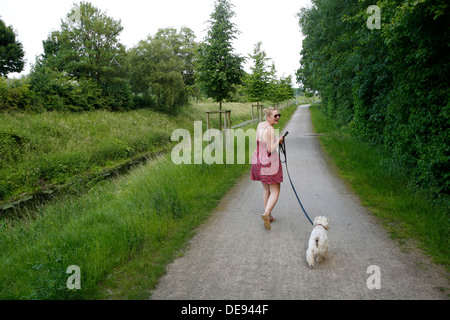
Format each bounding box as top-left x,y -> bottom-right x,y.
35,2 -> 130,109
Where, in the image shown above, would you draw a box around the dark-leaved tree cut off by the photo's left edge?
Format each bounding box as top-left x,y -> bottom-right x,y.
0,19 -> 25,77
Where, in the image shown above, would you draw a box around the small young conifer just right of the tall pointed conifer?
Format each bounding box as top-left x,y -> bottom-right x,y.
245,42 -> 270,104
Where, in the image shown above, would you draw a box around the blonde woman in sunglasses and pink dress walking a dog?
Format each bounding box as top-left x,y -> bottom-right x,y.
251,107 -> 283,230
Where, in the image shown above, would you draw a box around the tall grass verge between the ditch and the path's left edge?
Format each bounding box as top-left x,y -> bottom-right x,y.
0,107 -> 295,299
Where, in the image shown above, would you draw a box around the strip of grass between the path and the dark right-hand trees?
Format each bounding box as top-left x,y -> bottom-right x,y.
311,105 -> 450,268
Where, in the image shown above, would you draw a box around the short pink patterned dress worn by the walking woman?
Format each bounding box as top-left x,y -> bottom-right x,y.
250,127 -> 283,184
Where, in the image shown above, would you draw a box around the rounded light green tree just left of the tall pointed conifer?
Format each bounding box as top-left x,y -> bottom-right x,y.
129,28 -> 196,113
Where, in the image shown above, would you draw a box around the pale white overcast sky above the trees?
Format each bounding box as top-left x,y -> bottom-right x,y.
0,0 -> 310,82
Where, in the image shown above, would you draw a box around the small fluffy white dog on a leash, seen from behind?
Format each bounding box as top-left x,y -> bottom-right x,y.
306,217 -> 330,269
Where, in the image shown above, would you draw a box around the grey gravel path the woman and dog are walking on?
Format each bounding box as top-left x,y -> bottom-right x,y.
151,106 -> 448,300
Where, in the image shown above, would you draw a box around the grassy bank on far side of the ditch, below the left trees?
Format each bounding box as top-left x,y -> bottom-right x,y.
0,103 -> 251,205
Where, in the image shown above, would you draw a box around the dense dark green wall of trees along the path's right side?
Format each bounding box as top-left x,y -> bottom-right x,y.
297,0 -> 450,195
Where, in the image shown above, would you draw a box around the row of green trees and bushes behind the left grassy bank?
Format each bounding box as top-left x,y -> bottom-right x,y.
0,0 -> 293,113
